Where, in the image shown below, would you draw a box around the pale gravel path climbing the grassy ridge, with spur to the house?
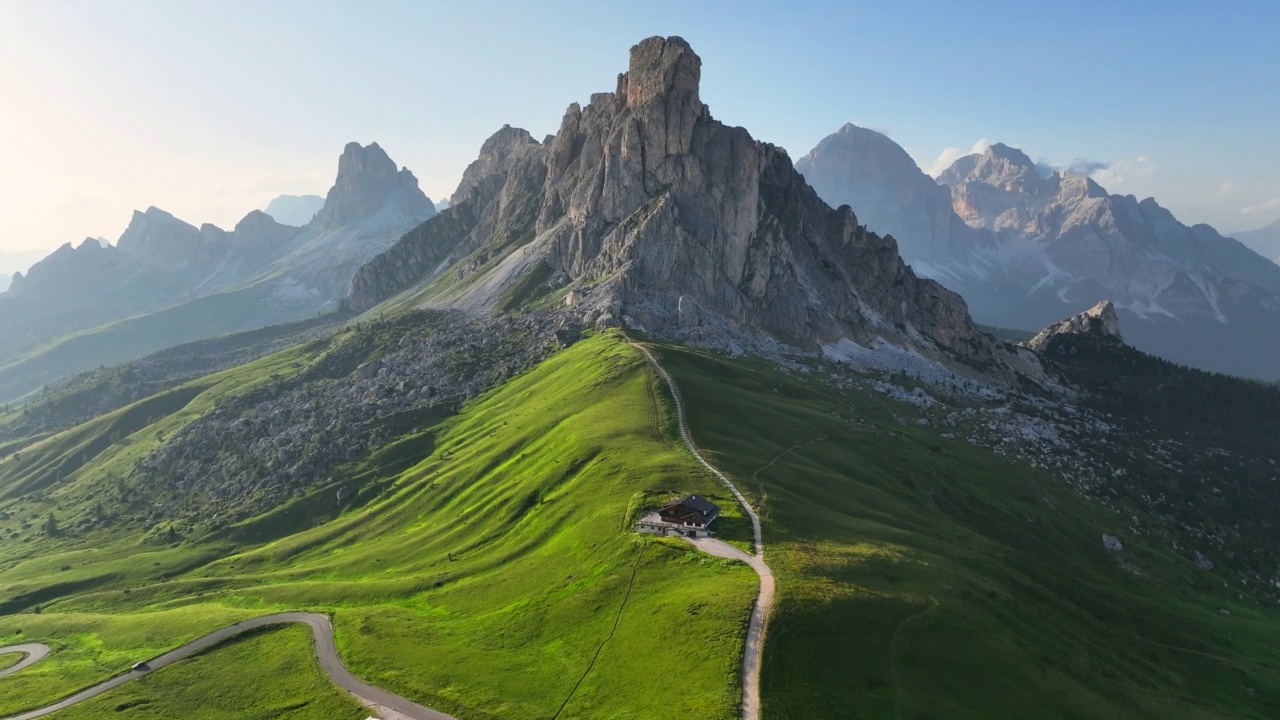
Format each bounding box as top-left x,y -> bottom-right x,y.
631,342 -> 774,720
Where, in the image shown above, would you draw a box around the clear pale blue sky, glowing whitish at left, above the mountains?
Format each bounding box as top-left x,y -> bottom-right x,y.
0,0 -> 1280,273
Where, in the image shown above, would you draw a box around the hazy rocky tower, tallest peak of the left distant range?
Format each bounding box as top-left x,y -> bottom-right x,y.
314,142 -> 435,228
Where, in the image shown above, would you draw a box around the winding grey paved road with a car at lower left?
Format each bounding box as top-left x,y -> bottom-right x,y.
0,612 -> 456,720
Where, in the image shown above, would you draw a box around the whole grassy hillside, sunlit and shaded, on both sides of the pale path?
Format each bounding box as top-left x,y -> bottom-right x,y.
0,325 -> 1280,720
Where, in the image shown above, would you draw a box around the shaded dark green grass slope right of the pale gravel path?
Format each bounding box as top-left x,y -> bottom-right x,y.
663,347 -> 1280,720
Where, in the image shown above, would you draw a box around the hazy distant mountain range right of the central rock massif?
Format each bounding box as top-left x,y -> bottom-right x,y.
796,124 -> 1280,379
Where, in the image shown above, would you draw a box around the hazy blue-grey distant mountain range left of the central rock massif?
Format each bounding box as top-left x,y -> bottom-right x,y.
0,142 -> 435,398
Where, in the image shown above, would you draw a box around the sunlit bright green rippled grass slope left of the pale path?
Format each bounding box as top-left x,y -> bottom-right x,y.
0,334 -> 756,719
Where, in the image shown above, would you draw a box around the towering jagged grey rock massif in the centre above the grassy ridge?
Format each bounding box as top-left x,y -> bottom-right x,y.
347,37 -> 1029,376
